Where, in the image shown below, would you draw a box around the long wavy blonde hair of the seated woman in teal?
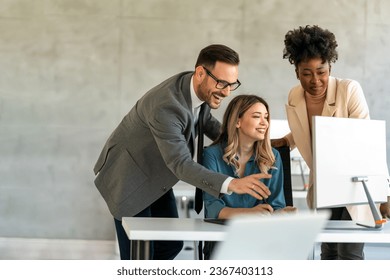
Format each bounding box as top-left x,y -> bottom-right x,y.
213,94 -> 275,173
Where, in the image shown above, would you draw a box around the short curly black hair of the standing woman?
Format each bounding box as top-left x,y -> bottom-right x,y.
283,25 -> 338,67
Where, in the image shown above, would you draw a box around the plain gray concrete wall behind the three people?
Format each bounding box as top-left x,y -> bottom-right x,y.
0,0 -> 390,239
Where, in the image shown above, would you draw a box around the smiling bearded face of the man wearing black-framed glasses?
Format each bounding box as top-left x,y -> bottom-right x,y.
194,62 -> 238,109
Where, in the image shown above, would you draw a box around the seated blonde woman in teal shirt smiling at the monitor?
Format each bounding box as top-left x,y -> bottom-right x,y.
203,95 -> 296,259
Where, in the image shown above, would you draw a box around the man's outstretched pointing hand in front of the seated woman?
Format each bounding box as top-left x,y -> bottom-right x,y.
228,173 -> 272,200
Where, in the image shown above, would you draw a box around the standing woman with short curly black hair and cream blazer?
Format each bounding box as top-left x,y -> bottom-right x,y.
272,25 -> 389,259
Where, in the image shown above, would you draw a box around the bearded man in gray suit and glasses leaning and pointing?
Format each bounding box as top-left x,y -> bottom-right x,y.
94,45 -> 269,259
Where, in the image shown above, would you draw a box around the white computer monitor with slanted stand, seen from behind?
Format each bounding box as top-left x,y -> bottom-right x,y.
312,116 -> 389,227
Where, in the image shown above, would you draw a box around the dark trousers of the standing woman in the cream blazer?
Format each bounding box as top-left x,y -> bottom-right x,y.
321,207 -> 364,260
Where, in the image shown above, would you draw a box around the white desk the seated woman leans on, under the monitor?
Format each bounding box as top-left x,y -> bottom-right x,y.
122,218 -> 390,259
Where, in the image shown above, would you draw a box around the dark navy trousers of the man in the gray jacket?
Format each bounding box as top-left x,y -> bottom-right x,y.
114,189 -> 183,260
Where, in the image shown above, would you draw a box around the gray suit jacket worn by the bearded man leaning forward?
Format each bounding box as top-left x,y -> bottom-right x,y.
94,72 -> 227,220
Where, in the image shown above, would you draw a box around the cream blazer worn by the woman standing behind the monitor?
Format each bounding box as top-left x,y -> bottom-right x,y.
286,77 -> 373,221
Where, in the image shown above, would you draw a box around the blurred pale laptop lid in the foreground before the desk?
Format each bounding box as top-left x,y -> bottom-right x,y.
211,211 -> 330,260
